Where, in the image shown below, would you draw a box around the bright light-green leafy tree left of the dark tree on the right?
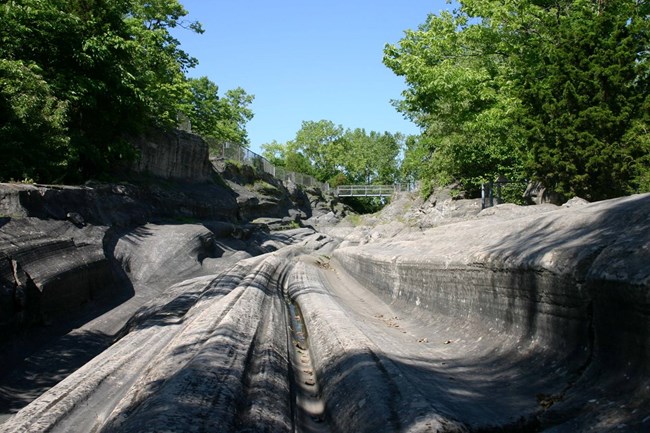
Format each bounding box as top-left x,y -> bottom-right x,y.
384,10 -> 523,197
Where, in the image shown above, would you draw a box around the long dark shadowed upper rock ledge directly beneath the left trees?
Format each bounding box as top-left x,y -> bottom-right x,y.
0,182 -> 237,227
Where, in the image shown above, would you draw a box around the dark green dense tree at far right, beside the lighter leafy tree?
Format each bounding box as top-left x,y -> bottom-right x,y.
514,0 -> 649,200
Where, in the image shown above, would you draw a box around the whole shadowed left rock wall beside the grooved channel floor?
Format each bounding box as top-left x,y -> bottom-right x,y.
0,132 -> 350,419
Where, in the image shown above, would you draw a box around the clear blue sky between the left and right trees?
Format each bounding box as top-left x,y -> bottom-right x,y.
175,0 -> 452,152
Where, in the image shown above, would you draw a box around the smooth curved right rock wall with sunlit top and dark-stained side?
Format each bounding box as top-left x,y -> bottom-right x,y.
334,195 -> 650,431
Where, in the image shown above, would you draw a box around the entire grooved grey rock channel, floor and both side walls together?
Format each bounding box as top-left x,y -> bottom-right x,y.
0,139 -> 650,432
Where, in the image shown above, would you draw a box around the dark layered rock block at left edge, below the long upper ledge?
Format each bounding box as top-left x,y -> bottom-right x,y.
0,218 -> 116,337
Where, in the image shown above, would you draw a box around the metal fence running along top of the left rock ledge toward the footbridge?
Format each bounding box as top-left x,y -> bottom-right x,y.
208,141 -> 330,192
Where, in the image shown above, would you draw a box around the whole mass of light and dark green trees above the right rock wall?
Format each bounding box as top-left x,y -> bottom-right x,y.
384,0 -> 650,200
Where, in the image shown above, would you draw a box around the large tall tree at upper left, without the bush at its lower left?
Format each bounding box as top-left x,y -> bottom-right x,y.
0,0 -> 200,181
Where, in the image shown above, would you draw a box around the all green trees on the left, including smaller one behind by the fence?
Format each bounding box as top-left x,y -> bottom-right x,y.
0,0 -> 252,182
